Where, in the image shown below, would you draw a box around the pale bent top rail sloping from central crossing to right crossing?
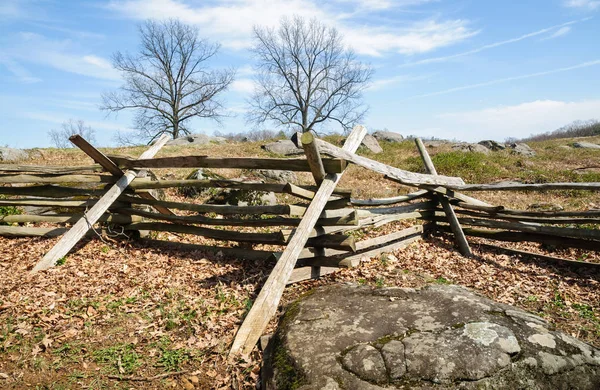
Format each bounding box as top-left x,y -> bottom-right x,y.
316,139 -> 465,186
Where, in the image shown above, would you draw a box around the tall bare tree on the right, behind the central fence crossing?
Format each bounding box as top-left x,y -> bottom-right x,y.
248,17 -> 372,132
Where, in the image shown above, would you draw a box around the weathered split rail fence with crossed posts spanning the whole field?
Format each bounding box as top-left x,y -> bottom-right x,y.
0,126 -> 600,356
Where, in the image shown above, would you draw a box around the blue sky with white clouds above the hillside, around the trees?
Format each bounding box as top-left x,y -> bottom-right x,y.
0,0 -> 600,148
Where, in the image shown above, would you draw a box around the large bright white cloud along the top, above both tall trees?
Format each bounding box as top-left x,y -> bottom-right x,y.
108,0 -> 477,56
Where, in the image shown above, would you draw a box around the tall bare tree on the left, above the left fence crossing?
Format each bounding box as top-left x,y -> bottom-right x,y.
101,19 -> 234,142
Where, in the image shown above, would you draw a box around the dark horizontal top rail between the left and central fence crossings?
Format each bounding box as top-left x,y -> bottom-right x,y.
109,156 -> 346,173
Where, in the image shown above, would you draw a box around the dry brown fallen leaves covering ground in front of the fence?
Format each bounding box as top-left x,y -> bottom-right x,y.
0,223 -> 600,389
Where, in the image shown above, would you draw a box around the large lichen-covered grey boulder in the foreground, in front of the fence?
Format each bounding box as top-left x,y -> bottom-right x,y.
262,284 -> 600,390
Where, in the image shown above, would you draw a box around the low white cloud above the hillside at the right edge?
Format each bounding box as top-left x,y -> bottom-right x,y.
438,100 -> 600,141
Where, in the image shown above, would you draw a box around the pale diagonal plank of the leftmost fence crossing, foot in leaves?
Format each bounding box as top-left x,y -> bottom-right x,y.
31,135 -> 169,272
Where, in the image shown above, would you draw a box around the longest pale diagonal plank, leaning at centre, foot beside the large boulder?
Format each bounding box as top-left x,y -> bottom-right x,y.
229,126 -> 367,356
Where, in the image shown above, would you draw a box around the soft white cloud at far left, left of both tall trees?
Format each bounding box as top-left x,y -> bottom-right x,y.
5,32 -> 119,80
